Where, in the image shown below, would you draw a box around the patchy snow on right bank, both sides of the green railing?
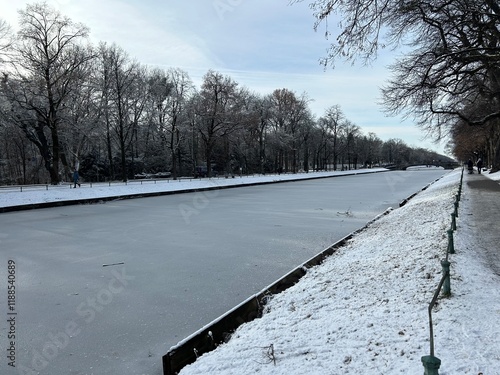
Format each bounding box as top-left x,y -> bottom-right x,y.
176,170 -> 500,375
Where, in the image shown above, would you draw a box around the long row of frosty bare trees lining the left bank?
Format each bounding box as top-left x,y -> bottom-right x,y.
0,3 -> 450,184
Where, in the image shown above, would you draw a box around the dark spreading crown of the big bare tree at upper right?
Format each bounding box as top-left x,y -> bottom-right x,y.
383,0 -> 500,126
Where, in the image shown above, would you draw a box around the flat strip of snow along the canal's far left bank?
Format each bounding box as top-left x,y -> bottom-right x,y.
0,168 -> 386,207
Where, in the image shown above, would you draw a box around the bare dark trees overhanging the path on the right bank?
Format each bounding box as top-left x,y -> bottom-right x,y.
297,0 -> 500,170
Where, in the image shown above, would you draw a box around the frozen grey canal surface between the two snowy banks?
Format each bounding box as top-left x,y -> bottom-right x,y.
0,170 -> 445,375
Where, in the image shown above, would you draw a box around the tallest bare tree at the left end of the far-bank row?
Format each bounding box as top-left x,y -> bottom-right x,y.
3,3 -> 93,184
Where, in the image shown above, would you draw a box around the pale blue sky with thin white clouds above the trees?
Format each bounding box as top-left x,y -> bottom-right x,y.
0,0 -> 450,153
